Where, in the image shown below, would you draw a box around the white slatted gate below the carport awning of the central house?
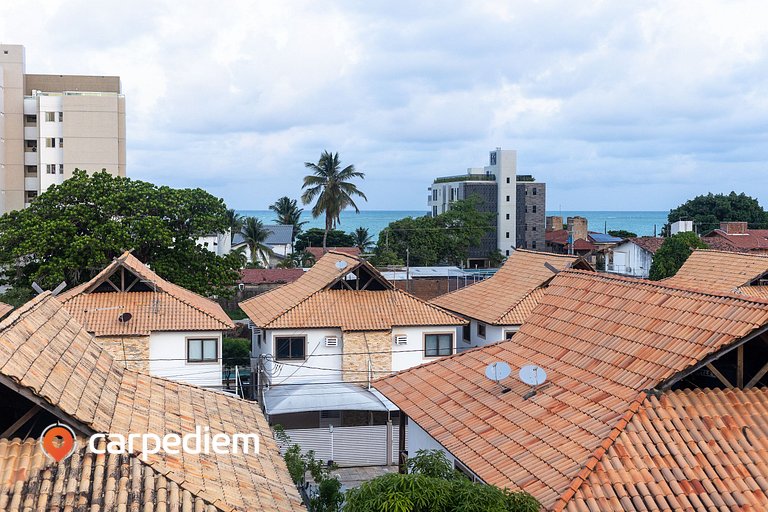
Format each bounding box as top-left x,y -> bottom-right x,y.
281,425 -> 400,467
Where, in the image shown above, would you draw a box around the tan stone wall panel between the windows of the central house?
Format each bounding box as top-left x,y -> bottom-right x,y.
341,331 -> 392,382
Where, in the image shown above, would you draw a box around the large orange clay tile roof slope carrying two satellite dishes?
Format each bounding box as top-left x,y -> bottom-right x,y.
374,270 -> 768,510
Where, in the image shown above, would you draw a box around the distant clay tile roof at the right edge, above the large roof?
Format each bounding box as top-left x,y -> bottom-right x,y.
663,249 -> 768,293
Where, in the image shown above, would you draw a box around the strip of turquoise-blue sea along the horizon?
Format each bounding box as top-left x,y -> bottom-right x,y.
238,210 -> 668,238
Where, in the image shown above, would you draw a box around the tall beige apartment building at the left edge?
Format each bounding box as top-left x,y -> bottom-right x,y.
0,45 -> 125,213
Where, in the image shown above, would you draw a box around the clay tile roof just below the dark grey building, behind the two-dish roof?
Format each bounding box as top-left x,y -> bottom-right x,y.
431,249 -> 580,325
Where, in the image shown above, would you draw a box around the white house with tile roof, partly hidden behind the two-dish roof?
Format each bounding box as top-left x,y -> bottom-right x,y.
431,249 -> 592,351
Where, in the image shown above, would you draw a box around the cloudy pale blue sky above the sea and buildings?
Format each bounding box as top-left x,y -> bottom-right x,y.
0,0 -> 768,210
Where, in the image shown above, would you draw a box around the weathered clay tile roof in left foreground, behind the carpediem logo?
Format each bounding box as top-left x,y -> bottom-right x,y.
0,293 -> 304,511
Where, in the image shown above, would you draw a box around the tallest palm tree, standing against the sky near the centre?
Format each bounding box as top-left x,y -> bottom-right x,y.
301,151 -> 368,249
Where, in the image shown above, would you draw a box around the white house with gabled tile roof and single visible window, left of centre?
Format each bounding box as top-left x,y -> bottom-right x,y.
59,252 -> 234,388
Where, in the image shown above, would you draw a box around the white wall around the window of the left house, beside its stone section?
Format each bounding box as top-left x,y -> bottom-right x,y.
149,331 -> 222,387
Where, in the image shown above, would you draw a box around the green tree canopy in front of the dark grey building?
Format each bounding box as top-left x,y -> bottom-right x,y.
373,196 -> 494,266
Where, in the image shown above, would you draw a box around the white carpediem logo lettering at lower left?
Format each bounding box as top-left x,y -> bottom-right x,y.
88,425 -> 259,461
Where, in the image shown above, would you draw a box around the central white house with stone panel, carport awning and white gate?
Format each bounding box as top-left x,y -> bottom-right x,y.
240,251 -> 466,465
